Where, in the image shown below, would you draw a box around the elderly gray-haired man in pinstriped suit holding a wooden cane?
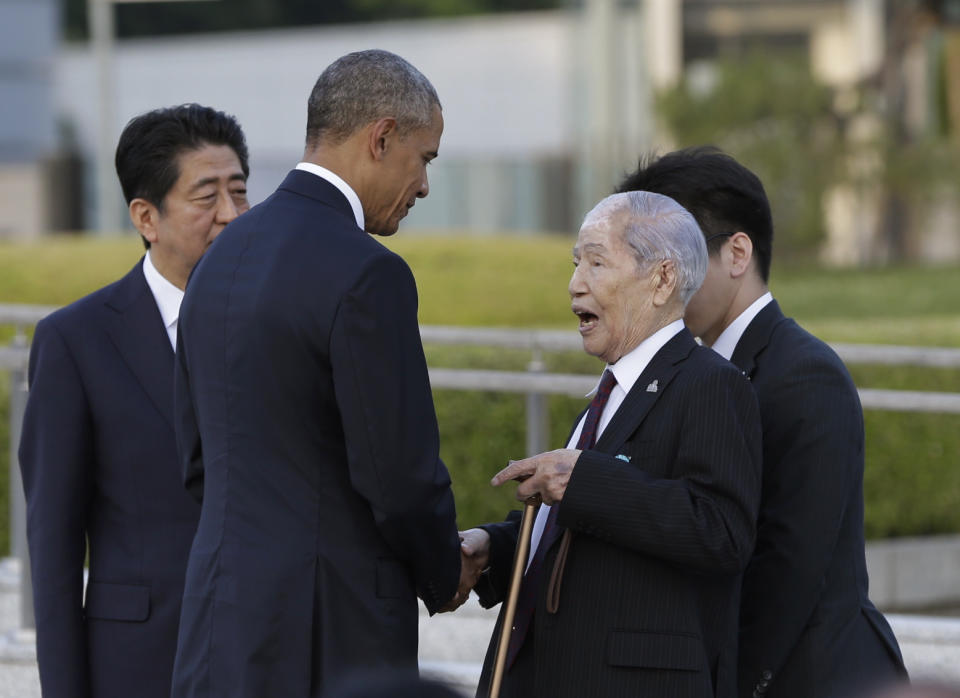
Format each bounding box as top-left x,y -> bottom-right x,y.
463,192 -> 760,698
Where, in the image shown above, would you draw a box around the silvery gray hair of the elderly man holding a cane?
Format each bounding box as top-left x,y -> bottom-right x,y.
584,191 -> 707,307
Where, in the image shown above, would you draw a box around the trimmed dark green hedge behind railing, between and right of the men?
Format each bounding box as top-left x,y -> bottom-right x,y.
436,348 -> 960,538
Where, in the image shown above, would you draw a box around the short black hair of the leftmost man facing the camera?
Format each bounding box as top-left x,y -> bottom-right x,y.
115,104 -> 250,247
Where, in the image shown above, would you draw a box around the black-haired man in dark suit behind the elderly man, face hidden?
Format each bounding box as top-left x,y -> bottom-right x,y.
620,148 -> 905,698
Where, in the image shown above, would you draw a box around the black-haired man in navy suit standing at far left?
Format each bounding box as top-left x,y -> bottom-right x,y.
20,104 -> 248,698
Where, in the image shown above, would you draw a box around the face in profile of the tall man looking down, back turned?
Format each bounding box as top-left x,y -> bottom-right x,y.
363,106 -> 443,235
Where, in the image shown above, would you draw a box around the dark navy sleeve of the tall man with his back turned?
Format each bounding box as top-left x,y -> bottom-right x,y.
330,254 -> 460,613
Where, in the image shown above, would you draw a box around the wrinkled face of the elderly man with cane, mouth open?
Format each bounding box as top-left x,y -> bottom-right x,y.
569,212 -> 656,364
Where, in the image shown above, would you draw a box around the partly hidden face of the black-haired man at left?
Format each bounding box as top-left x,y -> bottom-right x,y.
150,145 -> 250,288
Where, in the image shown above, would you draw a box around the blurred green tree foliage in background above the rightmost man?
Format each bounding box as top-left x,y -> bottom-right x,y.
657,50 -> 958,260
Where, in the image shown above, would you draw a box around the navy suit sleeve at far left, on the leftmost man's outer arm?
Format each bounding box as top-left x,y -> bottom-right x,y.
19,320 -> 94,698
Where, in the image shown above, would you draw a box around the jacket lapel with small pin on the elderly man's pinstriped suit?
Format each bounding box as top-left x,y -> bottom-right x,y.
594,328 -> 697,453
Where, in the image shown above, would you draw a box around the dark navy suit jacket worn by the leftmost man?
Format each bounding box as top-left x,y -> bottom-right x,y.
20,263 -> 199,698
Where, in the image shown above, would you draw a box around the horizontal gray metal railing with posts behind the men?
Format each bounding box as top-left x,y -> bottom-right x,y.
0,304 -> 960,628
